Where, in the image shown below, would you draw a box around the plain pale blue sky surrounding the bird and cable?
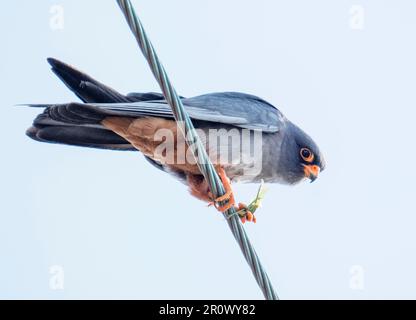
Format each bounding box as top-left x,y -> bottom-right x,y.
0,0 -> 416,299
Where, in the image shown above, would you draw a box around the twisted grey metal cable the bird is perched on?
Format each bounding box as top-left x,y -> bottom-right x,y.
117,0 -> 279,300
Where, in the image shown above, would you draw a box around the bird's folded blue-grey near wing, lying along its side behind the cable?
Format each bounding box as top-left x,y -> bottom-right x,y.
50,92 -> 284,132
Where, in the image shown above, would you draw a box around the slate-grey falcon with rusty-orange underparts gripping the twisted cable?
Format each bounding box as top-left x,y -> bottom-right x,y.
26,58 -> 326,222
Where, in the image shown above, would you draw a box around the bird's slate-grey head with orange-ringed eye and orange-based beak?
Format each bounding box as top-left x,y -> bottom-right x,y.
279,122 -> 325,184
